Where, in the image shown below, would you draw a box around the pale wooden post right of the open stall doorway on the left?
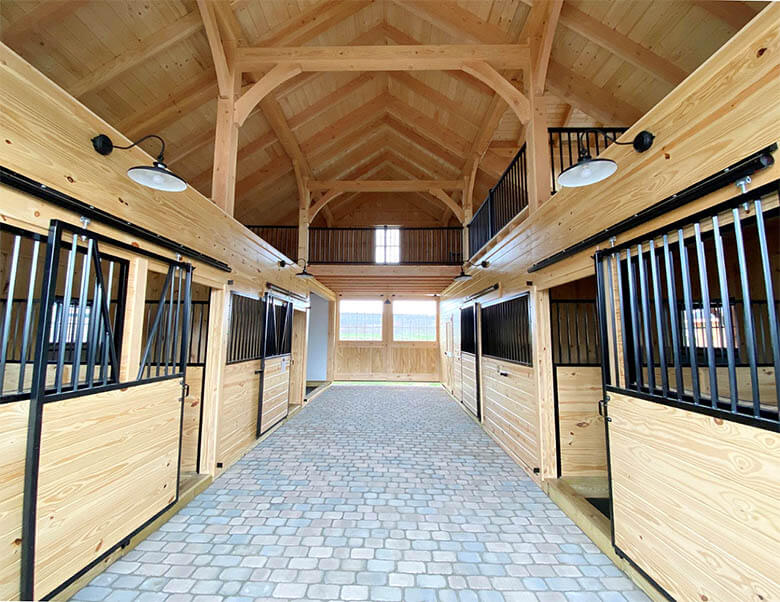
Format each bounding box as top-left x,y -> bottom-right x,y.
200,285 -> 230,475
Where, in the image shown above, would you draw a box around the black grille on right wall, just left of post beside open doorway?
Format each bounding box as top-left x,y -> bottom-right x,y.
481,294 -> 533,366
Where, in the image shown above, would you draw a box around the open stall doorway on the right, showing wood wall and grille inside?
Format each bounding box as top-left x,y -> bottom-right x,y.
550,276 -> 607,478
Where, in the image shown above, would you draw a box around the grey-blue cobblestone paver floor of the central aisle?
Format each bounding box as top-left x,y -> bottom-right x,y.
74,386 -> 647,602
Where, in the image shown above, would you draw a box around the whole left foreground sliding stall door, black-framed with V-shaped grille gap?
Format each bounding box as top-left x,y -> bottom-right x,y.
20,221 -> 192,599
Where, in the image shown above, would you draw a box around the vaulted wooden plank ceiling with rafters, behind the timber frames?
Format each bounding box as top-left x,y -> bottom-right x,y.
0,0 -> 765,231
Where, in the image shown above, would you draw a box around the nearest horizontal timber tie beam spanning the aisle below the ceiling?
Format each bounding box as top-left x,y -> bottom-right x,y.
237,44 -> 530,71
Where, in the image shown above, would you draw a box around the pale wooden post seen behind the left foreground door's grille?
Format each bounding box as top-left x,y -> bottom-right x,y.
119,257 -> 149,382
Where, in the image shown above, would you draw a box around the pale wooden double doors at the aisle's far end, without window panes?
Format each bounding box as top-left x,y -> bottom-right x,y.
334,296 -> 441,382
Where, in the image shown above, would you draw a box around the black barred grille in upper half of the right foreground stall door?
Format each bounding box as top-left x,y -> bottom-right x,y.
596,185 -> 780,430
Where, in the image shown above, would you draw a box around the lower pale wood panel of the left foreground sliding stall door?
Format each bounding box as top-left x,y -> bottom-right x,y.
35,379 -> 181,598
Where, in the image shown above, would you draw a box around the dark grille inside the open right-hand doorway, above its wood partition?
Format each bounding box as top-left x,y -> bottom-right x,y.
550,299 -> 601,366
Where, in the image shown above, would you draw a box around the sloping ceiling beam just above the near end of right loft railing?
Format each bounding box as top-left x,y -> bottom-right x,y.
547,61 -> 642,126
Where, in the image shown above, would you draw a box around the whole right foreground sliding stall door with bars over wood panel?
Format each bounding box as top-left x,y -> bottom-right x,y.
596,193 -> 780,601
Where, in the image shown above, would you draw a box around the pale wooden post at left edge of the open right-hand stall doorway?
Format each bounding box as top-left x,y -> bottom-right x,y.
531,287 -> 558,481
